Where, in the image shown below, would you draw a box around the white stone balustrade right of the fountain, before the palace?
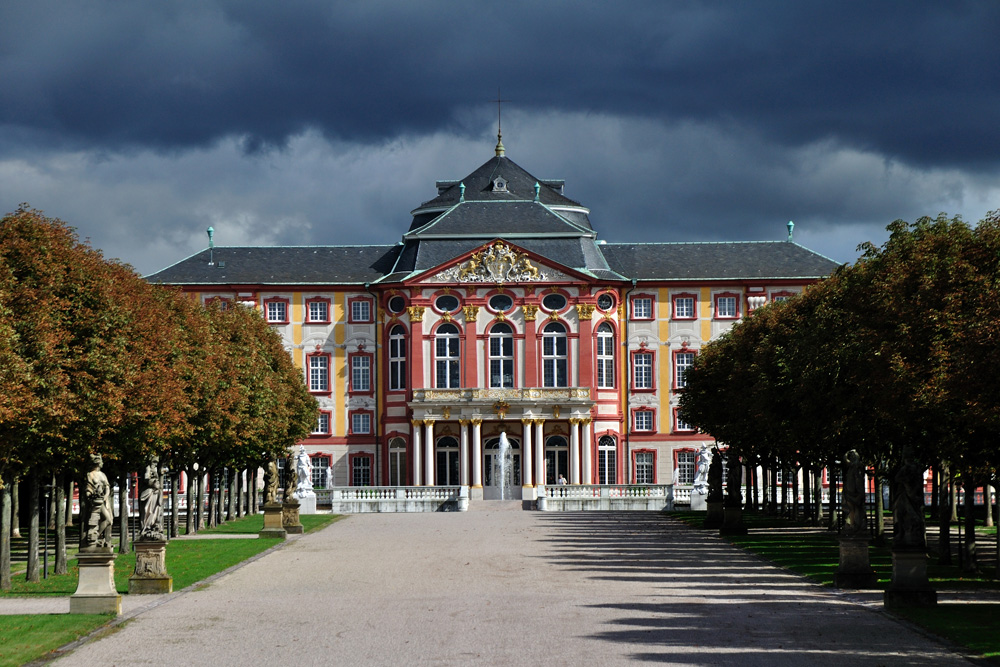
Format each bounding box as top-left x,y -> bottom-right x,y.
538,484 -> 674,512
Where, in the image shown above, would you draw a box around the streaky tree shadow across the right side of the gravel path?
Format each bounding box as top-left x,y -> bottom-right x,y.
539,512 -> 961,665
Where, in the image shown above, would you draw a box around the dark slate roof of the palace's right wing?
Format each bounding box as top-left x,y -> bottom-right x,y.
599,241 -> 840,280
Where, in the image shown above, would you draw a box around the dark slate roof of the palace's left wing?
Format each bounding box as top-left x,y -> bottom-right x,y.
146,244 -> 401,285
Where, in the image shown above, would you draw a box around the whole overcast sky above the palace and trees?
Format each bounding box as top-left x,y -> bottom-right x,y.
0,0 -> 1000,273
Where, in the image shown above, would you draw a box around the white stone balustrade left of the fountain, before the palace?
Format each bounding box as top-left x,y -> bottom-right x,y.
315,486 -> 469,514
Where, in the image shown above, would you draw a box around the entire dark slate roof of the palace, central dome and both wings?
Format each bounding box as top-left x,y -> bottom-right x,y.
147,155 -> 838,285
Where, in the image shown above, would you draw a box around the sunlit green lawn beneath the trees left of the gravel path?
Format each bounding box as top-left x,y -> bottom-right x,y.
0,514 -> 341,666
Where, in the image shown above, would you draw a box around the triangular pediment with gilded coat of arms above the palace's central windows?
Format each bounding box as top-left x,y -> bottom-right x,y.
418,239 -> 587,285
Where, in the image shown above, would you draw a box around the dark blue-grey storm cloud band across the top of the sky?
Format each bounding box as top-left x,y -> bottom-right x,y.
0,0 -> 1000,168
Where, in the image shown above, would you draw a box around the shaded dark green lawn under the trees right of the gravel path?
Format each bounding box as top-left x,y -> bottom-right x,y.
672,512 -> 1000,664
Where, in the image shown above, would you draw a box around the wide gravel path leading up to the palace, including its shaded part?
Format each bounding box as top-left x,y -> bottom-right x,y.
50,503 -> 970,667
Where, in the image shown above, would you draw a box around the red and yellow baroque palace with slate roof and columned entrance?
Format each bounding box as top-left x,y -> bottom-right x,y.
148,142 -> 837,500
